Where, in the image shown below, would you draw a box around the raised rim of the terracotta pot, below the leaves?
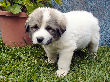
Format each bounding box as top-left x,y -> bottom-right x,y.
0,11 -> 28,17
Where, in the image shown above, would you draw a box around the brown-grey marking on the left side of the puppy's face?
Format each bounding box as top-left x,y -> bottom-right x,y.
25,9 -> 43,38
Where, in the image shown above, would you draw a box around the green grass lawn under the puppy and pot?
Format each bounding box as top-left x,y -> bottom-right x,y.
0,40 -> 110,82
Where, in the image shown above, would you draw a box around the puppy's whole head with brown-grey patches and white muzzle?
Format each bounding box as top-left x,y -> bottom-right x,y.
25,8 -> 66,45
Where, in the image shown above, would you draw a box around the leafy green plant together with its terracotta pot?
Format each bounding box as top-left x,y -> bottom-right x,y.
0,0 -> 62,47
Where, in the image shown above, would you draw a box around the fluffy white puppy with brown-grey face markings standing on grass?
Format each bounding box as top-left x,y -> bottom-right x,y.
26,8 -> 100,77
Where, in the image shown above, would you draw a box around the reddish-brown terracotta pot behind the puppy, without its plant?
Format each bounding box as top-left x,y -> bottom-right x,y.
0,11 -> 31,47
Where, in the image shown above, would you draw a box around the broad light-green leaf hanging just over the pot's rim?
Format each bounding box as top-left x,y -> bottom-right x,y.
6,4 -> 22,14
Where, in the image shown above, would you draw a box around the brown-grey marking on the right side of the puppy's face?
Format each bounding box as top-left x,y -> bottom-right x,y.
45,9 -> 66,40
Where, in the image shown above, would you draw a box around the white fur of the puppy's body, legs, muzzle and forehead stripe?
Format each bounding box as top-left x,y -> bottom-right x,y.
27,7 -> 100,76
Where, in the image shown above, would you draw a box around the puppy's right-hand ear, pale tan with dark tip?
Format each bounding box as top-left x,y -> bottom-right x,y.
50,9 -> 67,36
